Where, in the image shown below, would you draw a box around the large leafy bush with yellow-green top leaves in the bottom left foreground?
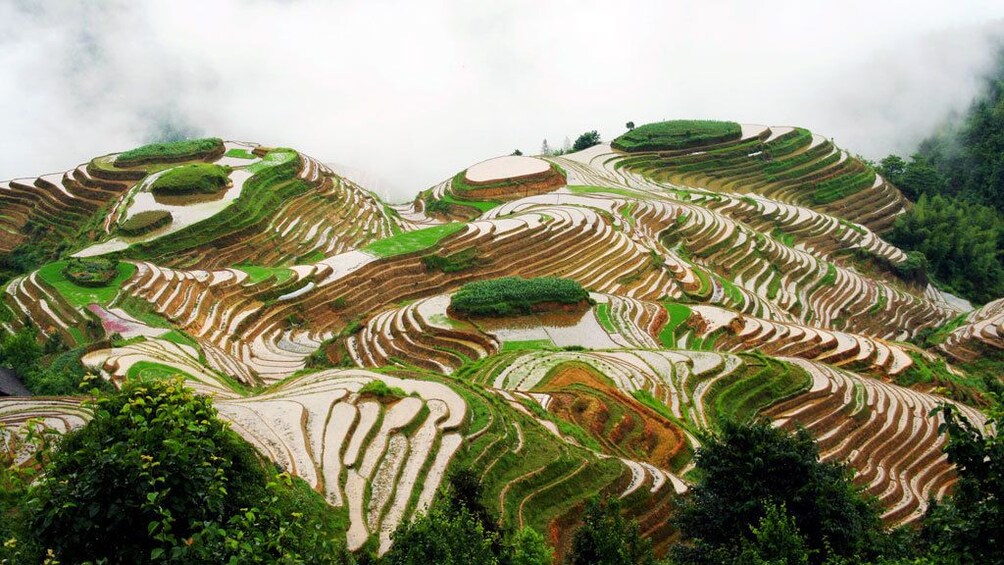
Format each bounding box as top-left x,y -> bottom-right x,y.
30,378 -> 353,563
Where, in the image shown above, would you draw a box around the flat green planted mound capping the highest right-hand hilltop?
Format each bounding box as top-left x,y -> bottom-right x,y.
611,119 -> 742,152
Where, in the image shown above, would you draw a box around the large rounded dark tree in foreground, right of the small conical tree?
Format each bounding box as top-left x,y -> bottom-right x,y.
675,419 -> 885,563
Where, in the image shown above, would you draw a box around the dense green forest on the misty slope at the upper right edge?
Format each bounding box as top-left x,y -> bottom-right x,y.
879,51 -> 1004,302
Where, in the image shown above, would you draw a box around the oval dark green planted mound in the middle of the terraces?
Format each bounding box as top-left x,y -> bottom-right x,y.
450,277 -> 589,317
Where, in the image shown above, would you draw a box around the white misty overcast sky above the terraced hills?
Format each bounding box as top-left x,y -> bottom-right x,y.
0,0 -> 1004,201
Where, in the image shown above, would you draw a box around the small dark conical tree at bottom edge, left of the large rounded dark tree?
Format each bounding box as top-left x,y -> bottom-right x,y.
565,498 -> 655,565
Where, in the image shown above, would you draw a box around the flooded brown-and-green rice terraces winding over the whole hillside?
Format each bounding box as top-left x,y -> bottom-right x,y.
0,121 -> 1004,553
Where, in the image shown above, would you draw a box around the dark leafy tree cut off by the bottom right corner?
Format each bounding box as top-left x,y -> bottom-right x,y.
921,381 -> 1004,564
